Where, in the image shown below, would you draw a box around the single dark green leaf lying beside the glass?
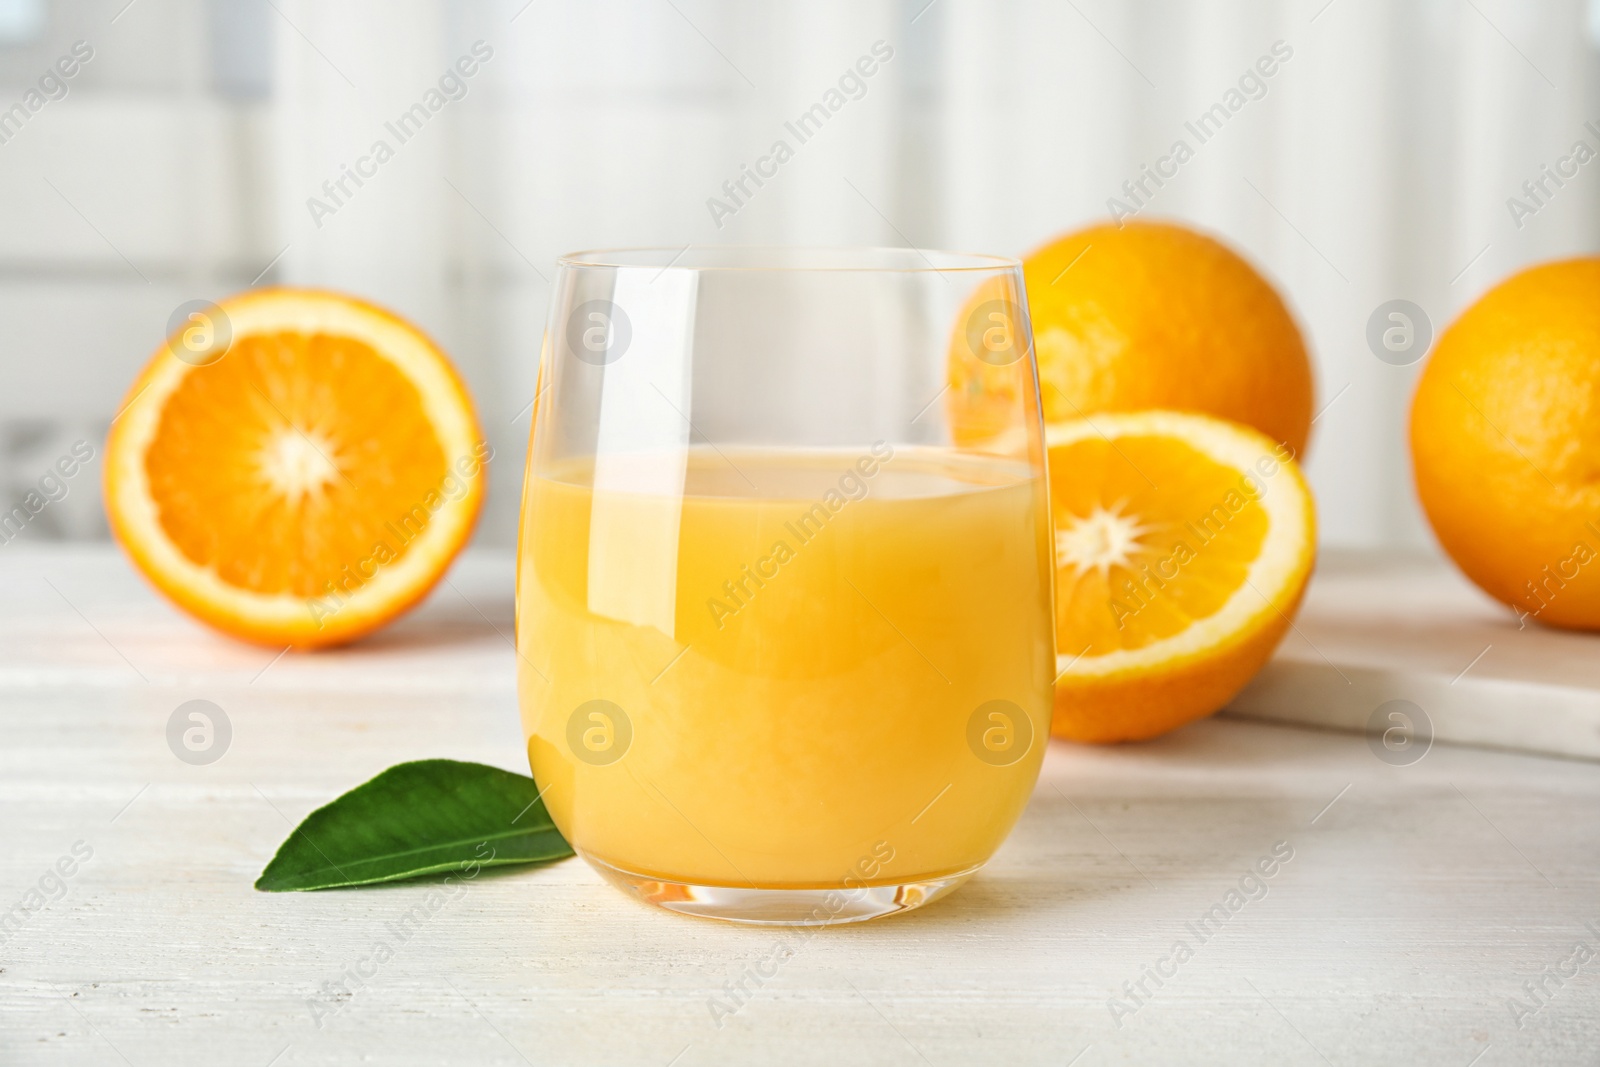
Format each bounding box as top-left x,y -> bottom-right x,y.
256,760 -> 573,893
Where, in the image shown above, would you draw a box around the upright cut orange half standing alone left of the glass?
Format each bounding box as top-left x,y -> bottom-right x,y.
106,288 -> 490,648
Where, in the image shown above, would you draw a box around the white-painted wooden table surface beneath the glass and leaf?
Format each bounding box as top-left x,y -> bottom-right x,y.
0,544 -> 1600,1067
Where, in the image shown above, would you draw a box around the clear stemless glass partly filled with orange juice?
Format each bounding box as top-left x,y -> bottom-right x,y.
517,248 -> 1054,925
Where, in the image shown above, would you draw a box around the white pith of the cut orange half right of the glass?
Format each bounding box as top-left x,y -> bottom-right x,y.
1045,411 -> 1315,678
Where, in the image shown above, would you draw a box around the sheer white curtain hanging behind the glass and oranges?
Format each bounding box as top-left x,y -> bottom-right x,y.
272,0 -> 1600,545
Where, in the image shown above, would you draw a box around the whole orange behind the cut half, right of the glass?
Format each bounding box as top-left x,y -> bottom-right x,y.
1022,222 -> 1312,456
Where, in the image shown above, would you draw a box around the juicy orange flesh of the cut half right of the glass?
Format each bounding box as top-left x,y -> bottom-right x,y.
1050,437 -> 1267,656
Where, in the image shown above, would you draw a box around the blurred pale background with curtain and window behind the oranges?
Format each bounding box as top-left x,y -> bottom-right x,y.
0,0 -> 1600,545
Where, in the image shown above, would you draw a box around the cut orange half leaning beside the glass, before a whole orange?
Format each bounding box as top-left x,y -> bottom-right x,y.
1045,411 -> 1317,741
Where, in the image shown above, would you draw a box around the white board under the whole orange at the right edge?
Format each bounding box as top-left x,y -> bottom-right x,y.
1224,552 -> 1600,763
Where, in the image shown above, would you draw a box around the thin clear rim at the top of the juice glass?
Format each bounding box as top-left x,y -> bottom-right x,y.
555,245 -> 1022,274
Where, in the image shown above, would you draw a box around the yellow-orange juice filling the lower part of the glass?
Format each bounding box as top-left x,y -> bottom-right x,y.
517,443 -> 1054,889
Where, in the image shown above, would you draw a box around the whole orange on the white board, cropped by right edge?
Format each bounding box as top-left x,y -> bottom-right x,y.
1411,258 -> 1600,629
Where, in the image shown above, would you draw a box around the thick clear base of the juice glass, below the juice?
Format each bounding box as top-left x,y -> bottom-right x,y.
578,849 -> 982,926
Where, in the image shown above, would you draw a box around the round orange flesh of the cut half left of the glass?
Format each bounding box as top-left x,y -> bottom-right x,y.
144,331 -> 450,597
